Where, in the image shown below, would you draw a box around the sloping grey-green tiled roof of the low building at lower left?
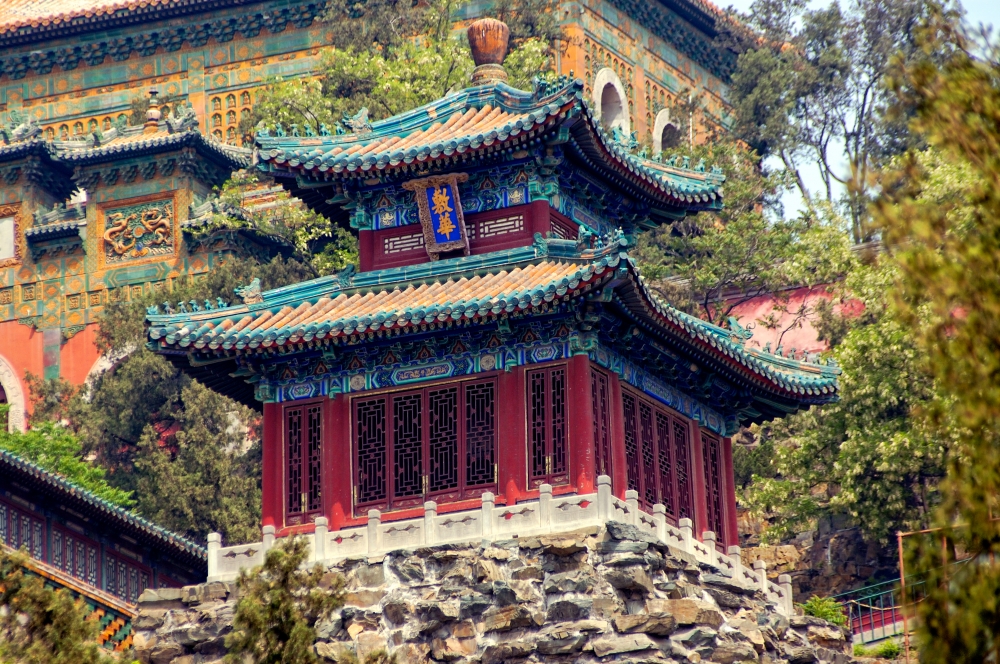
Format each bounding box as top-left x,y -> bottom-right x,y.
0,450 -> 208,565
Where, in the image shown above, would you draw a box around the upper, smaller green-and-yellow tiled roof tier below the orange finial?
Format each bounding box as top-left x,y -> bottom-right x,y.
256,80 -> 724,208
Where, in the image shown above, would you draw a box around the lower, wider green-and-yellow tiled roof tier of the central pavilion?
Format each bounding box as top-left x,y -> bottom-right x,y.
147,240 -> 839,401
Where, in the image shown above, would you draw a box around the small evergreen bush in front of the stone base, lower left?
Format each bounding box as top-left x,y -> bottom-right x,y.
225,537 -> 344,664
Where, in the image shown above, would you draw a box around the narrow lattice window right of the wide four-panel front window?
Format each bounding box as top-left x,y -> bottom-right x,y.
527,366 -> 569,488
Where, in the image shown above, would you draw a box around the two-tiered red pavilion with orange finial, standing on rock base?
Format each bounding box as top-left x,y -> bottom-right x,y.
148,19 -> 838,578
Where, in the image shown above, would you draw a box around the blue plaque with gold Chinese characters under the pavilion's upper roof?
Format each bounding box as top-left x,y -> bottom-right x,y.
402,173 -> 469,261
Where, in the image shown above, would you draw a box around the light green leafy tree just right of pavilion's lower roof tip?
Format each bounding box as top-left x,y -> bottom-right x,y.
741,261 -> 948,544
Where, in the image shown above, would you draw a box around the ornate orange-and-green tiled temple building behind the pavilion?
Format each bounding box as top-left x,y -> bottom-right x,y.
0,0 -> 736,428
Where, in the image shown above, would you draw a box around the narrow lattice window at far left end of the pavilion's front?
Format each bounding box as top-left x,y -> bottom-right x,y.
285,403 -> 323,523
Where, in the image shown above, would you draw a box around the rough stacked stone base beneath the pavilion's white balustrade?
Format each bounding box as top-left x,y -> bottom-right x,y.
133,522 -> 852,664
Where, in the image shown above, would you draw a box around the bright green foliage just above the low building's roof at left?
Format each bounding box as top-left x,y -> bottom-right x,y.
0,421 -> 135,507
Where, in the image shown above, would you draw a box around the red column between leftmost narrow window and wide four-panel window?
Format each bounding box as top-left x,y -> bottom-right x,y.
323,394 -> 354,530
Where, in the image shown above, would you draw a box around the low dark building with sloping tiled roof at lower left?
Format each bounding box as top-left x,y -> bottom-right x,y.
0,450 -> 207,651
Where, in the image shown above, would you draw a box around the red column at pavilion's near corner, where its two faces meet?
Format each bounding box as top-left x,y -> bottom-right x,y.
567,354 -> 597,493
